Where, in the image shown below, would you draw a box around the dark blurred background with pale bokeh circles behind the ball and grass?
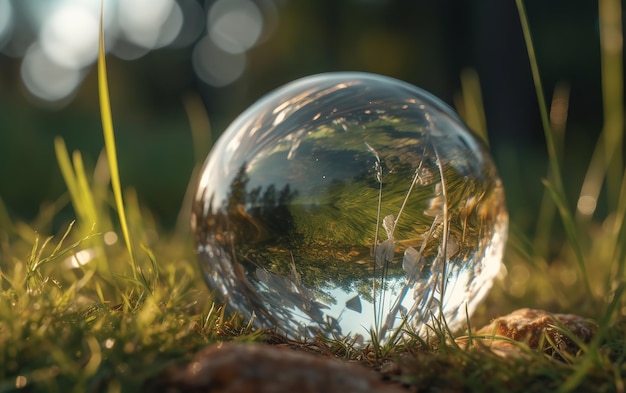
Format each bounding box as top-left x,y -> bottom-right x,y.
0,0 -> 602,230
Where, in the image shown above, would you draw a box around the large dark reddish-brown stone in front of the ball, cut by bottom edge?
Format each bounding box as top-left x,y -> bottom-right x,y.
153,343 -> 406,393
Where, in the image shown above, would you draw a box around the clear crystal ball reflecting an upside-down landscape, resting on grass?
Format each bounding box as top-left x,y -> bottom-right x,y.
192,73 -> 508,342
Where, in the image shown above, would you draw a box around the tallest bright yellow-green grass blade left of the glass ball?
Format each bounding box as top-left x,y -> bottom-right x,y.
98,2 -> 137,279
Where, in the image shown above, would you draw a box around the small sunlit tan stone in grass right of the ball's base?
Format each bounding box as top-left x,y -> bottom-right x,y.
456,308 -> 598,357
